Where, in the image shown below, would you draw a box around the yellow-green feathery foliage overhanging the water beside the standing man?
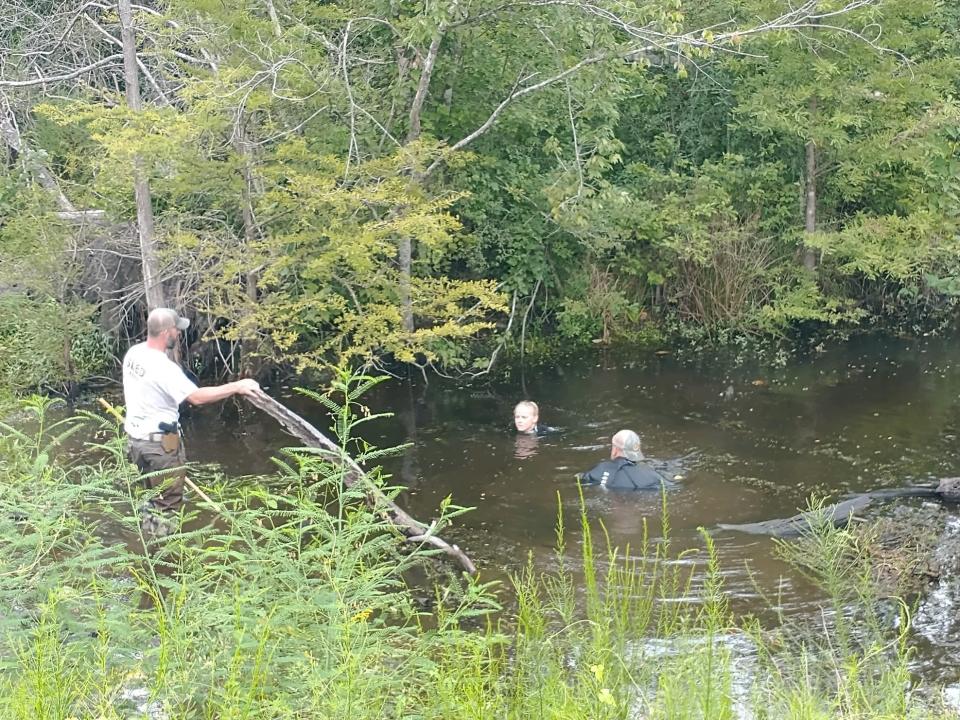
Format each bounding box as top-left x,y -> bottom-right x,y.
208,144 -> 505,369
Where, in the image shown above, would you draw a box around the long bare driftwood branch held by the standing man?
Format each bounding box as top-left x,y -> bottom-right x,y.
246,391 -> 477,575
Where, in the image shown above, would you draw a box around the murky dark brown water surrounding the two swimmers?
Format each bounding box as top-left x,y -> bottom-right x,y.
186,338 -> 960,682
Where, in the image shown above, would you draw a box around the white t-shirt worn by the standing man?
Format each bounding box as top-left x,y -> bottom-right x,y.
123,342 -> 197,440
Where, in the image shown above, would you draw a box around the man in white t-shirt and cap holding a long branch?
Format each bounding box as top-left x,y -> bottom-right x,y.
123,308 -> 260,532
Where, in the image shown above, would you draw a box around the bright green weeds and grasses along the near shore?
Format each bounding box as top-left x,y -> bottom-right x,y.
0,375 -> 953,720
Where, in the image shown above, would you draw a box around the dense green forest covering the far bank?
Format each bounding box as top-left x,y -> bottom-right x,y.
0,0 -> 960,392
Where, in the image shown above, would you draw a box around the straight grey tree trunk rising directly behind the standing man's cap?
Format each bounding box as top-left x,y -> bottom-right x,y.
117,0 -> 167,310
